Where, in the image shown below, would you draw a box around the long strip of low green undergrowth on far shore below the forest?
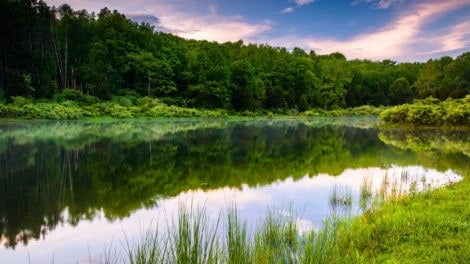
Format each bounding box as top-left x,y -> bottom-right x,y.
0,95 -> 384,120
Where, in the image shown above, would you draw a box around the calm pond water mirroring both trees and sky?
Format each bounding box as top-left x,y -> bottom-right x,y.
0,118 -> 470,263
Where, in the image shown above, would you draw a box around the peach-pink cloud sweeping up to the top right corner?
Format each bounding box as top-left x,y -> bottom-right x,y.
258,0 -> 470,61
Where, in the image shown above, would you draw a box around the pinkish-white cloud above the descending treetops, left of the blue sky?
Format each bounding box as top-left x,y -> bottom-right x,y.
46,0 -> 274,42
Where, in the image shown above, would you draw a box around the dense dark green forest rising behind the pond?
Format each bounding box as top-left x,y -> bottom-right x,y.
0,0 -> 470,112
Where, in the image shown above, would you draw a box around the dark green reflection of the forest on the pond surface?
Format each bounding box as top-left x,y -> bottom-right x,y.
0,122 -> 466,247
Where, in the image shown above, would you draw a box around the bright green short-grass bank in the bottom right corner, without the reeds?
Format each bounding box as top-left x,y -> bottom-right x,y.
338,173 -> 470,263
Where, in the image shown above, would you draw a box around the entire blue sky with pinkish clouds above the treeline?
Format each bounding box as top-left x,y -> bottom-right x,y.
45,0 -> 470,61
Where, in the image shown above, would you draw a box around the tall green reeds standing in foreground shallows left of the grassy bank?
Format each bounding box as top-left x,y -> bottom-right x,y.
110,205 -> 356,264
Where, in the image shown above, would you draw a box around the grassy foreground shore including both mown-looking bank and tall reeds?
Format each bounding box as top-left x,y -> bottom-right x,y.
107,170 -> 470,263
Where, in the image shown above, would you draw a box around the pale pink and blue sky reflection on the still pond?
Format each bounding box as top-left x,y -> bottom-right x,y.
0,166 -> 461,263
